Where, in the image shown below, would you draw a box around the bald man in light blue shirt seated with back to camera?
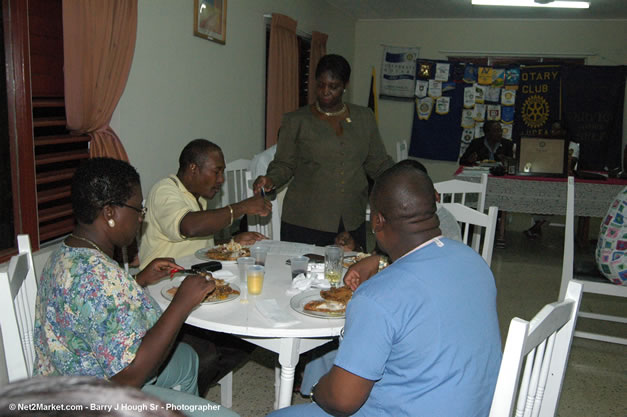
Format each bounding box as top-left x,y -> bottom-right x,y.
270,165 -> 501,417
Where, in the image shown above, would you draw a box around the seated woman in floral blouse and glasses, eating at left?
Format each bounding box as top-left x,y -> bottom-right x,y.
33,158 -> 236,416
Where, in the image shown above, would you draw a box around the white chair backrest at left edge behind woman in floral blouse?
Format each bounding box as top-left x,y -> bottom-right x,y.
0,235 -> 37,382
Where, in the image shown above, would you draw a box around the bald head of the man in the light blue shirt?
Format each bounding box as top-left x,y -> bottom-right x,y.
371,163 -> 437,228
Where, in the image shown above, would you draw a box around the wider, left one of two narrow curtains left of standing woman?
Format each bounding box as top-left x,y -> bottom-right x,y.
266,13 -> 298,148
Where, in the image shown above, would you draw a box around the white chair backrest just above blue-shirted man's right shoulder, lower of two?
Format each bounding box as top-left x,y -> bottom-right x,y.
442,203 -> 499,265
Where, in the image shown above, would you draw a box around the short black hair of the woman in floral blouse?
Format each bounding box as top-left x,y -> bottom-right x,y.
72,158 -> 140,224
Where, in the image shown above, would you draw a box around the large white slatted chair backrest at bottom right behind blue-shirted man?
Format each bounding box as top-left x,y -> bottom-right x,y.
490,282 -> 582,417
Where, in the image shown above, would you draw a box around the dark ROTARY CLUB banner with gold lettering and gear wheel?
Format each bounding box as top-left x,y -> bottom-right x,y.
514,65 -> 562,139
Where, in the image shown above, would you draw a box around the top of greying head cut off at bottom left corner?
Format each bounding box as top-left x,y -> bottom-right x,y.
0,376 -> 183,417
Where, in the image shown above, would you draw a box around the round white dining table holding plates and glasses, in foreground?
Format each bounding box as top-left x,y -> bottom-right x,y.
148,240 -> 344,409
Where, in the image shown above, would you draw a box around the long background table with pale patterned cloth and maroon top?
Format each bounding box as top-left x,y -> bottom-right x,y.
456,175 -> 627,217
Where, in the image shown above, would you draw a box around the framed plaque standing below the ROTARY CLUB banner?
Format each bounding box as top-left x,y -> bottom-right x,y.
517,136 -> 568,177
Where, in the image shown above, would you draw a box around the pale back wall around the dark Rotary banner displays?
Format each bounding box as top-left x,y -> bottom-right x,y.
352,19 -> 627,181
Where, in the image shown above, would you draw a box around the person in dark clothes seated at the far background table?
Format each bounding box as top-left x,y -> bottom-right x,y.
459,120 -> 513,165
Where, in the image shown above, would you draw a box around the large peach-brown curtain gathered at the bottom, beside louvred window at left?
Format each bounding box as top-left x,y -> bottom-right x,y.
63,0 -> 137,161
